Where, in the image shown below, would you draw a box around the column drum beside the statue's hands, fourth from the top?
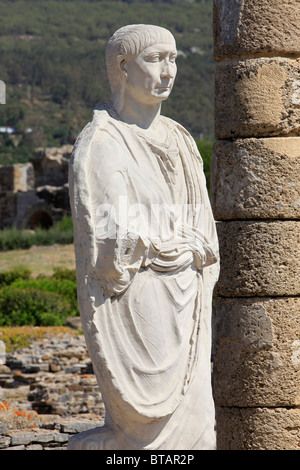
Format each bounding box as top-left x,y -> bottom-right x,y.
215,221 -> 300,297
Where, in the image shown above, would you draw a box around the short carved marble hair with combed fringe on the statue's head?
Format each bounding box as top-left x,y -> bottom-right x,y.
106,24 -> 175,92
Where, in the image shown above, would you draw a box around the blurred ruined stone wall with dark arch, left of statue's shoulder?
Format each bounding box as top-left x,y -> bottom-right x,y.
0,145 -> 73,229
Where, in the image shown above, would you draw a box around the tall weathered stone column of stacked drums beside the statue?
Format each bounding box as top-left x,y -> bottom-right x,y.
211,0 -> 300,450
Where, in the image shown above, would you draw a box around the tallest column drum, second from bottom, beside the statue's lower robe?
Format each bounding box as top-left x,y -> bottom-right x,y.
213,297 -> 300,407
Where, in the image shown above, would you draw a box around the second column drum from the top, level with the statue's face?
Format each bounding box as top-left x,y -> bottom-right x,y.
215,58 -> 300,139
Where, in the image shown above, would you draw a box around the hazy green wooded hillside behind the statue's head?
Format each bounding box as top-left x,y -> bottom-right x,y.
0,0 -> 214,164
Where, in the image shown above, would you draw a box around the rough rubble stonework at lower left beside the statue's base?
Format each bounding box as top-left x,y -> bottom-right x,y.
0,332 -> 105,450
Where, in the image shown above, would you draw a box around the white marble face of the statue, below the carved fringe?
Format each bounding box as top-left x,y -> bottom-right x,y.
124,44 -> 177,105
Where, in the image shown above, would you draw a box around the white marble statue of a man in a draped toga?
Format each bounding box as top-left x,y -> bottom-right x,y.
69,25 -> 219,450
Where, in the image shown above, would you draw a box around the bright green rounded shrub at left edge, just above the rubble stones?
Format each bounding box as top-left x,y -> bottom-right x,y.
0,286 -> 72,326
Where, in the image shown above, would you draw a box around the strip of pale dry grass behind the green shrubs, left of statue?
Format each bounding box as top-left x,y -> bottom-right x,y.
0,245 -> 75,277
